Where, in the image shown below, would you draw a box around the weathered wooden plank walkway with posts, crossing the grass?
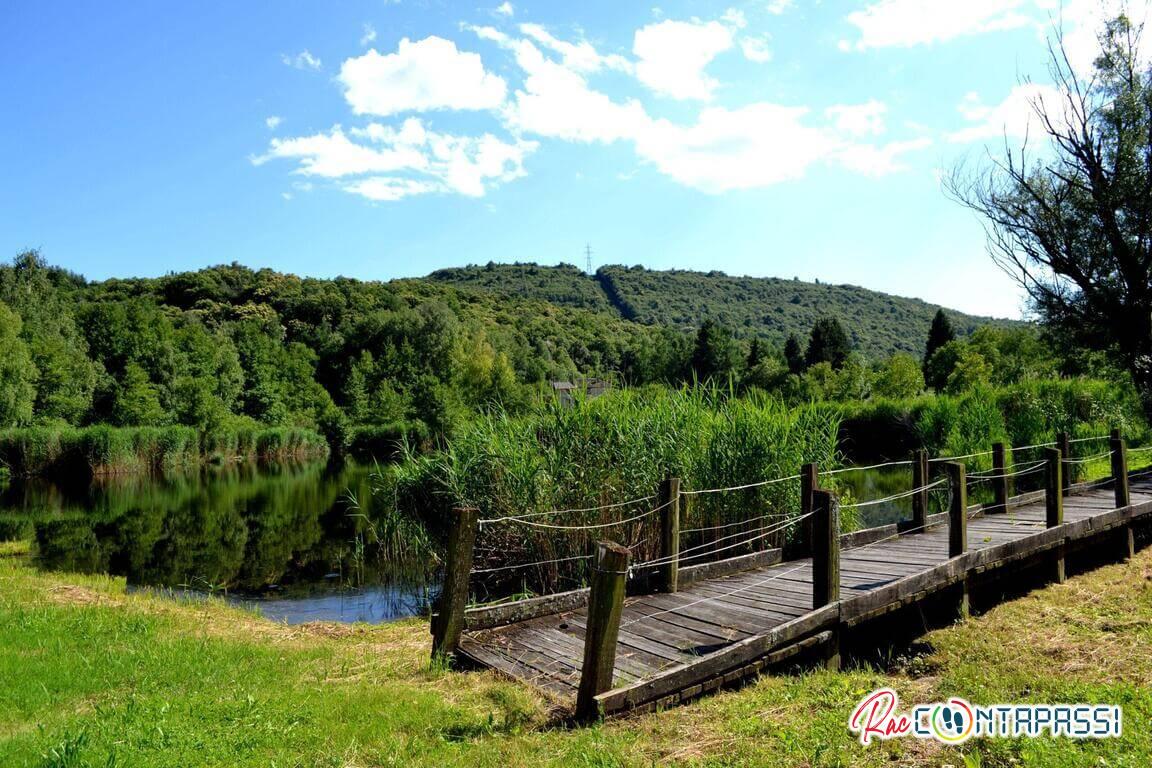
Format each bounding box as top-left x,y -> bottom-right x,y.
433,438 -> 1152,718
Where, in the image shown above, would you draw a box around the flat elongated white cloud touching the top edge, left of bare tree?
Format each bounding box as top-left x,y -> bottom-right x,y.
840,0 -> 1036,51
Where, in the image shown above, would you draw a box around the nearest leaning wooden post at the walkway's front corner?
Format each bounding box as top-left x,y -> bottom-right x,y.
576,541 -> 628,721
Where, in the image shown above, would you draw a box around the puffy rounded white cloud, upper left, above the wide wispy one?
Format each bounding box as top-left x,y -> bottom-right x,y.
339,37 -> 506,115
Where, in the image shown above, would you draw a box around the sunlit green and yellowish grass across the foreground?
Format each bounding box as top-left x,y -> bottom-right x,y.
0,543 -> 1152,768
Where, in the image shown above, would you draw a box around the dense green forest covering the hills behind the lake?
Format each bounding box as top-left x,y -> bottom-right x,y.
0,252 -> 1107,463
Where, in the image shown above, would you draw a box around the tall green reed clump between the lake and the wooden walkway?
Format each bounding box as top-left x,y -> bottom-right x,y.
378,387 -> 839,592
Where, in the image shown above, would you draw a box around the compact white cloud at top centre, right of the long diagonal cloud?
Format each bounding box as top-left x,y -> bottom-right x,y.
632,21 -> 733,101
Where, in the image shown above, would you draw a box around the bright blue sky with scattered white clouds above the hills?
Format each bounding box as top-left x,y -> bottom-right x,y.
0,0 -> 1143,317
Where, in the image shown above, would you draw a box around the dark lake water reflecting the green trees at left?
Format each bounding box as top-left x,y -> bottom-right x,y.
0,463 -> 438,623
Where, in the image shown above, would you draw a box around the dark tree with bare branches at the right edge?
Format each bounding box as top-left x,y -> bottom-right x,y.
946,15 -> 1152,418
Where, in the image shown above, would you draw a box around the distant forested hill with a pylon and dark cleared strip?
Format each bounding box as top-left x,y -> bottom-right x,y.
427,263 -> 1003,360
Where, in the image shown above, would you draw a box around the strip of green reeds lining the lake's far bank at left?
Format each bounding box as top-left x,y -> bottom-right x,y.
0,425 -> 328,476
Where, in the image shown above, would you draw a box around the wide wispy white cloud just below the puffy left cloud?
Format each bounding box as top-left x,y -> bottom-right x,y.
252,117 -> 537,200
